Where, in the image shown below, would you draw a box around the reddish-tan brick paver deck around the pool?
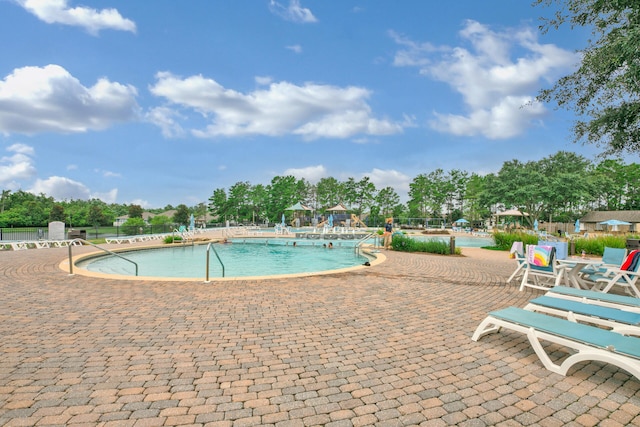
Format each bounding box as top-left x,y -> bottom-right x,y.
0,237 -> 640,427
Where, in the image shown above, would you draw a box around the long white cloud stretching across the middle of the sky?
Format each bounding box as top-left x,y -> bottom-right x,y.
150,72 -> 402,140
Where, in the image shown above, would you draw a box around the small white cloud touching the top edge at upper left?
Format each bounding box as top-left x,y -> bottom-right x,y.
17,0 -> 136,35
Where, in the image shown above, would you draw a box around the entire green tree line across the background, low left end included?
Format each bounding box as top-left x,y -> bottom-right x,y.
0,151 -> 640,231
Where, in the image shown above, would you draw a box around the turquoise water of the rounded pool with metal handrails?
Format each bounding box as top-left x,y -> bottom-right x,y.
76,239 -> 371,279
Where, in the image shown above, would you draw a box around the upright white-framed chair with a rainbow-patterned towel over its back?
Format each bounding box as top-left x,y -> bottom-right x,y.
520,245 -> 564,291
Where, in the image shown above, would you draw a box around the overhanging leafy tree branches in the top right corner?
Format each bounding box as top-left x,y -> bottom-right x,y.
535,0 -> 640,154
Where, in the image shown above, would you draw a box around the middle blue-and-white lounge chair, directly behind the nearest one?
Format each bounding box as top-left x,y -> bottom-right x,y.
524,295 -> 640,337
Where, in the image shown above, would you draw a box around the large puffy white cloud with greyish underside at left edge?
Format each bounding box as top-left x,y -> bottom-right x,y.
0,65 -> 139,134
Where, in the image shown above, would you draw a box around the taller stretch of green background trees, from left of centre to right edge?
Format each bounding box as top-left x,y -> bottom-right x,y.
209,151 -> 640,229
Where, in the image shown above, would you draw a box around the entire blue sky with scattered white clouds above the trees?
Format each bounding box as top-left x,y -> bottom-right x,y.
0,0 -> 632,208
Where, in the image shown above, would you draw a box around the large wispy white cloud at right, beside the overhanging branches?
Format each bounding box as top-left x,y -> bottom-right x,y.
391,21 -> 578,139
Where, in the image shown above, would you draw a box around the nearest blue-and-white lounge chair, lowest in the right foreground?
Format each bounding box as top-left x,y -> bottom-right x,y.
471,307 -> 640,380
